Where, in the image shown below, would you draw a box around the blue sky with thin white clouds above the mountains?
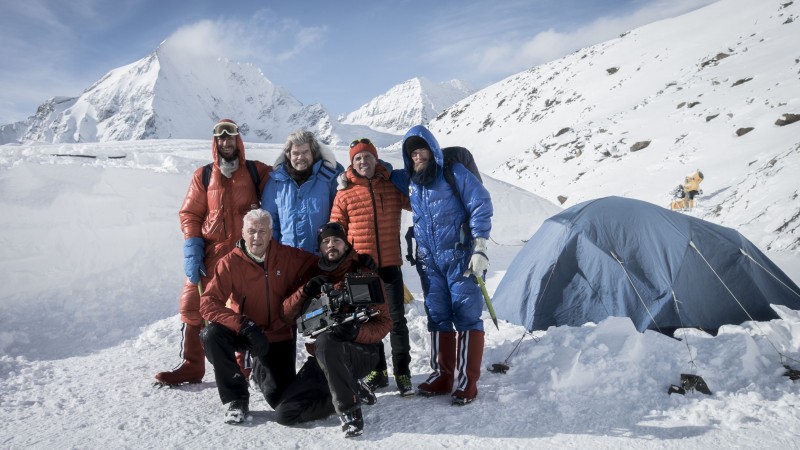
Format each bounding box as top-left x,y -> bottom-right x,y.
0,0 -> 714,124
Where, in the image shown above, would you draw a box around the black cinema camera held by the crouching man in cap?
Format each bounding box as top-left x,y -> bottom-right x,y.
297,273 -> 384,337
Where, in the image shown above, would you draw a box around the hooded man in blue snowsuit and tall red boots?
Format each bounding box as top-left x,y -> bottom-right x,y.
403,125 -> 493,405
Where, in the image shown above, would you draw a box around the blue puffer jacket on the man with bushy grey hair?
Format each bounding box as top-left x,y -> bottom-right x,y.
261,159 -> 344,254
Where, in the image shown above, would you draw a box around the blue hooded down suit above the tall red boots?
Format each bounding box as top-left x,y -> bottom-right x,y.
403,125 -> 493,331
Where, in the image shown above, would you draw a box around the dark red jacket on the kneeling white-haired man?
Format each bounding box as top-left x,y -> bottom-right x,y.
200,240 -> 318,342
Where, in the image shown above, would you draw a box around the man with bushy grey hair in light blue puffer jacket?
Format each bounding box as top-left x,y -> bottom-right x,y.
261,130 -> 344,253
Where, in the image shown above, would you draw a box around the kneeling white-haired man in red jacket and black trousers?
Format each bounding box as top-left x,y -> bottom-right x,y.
200,209 -> 318,424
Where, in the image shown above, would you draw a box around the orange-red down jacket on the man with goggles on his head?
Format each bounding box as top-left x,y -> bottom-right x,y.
178,135 -> 272,271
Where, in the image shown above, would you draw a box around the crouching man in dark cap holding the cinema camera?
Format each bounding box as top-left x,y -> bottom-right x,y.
275,222 -> 392,437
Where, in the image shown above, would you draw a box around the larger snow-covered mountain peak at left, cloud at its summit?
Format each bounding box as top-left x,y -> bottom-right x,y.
0,41 -> 332,143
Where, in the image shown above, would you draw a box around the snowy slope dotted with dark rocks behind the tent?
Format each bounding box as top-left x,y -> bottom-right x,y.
422,0 -> 800,249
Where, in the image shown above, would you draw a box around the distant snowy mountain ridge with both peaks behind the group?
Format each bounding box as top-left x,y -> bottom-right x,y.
0,50 -> 472,146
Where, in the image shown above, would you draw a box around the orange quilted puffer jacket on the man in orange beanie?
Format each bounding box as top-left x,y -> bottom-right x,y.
331,164 -> 410,267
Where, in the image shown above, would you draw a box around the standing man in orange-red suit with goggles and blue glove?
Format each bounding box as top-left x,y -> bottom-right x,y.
156,119 -> 272,385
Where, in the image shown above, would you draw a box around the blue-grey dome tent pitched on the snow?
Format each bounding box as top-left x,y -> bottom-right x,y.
494,197 -> 800,332
